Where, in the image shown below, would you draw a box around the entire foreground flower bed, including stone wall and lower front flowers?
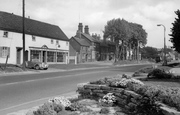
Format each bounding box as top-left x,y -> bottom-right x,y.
26,75 -> 180,115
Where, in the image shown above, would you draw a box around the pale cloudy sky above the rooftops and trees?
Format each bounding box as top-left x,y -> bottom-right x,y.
0,0 -> 180,48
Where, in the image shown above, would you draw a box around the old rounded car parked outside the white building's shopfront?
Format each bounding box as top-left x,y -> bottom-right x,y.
26,61 -> 48,70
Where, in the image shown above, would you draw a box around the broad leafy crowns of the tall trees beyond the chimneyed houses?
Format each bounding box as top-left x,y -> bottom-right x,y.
104,18 -> 147,61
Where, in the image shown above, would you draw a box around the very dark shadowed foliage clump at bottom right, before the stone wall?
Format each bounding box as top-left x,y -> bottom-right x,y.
129,95 -> 163,115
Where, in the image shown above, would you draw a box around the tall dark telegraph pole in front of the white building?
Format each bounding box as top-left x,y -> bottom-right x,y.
22,0 -> 26,70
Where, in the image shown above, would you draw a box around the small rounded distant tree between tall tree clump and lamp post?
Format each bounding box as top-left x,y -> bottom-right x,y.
141,46 -> 159,59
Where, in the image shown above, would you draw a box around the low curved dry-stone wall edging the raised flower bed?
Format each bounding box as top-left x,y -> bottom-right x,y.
77,83 -> 180,115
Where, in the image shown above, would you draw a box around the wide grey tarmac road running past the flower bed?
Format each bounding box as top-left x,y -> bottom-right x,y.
0,65 -> 151,114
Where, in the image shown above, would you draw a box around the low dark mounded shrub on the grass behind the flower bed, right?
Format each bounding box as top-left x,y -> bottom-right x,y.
147,68 -> 173,79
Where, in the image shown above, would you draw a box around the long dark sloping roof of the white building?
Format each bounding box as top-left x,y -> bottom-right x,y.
0,11 -> 69,41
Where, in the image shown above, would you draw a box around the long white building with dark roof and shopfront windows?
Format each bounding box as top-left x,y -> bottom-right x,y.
0,12 -> 69,64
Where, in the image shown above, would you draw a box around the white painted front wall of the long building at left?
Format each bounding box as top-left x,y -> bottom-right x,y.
0,30 -> 69,64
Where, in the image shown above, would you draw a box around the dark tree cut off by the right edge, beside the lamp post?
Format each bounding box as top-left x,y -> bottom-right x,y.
170,10 -> 180,53
